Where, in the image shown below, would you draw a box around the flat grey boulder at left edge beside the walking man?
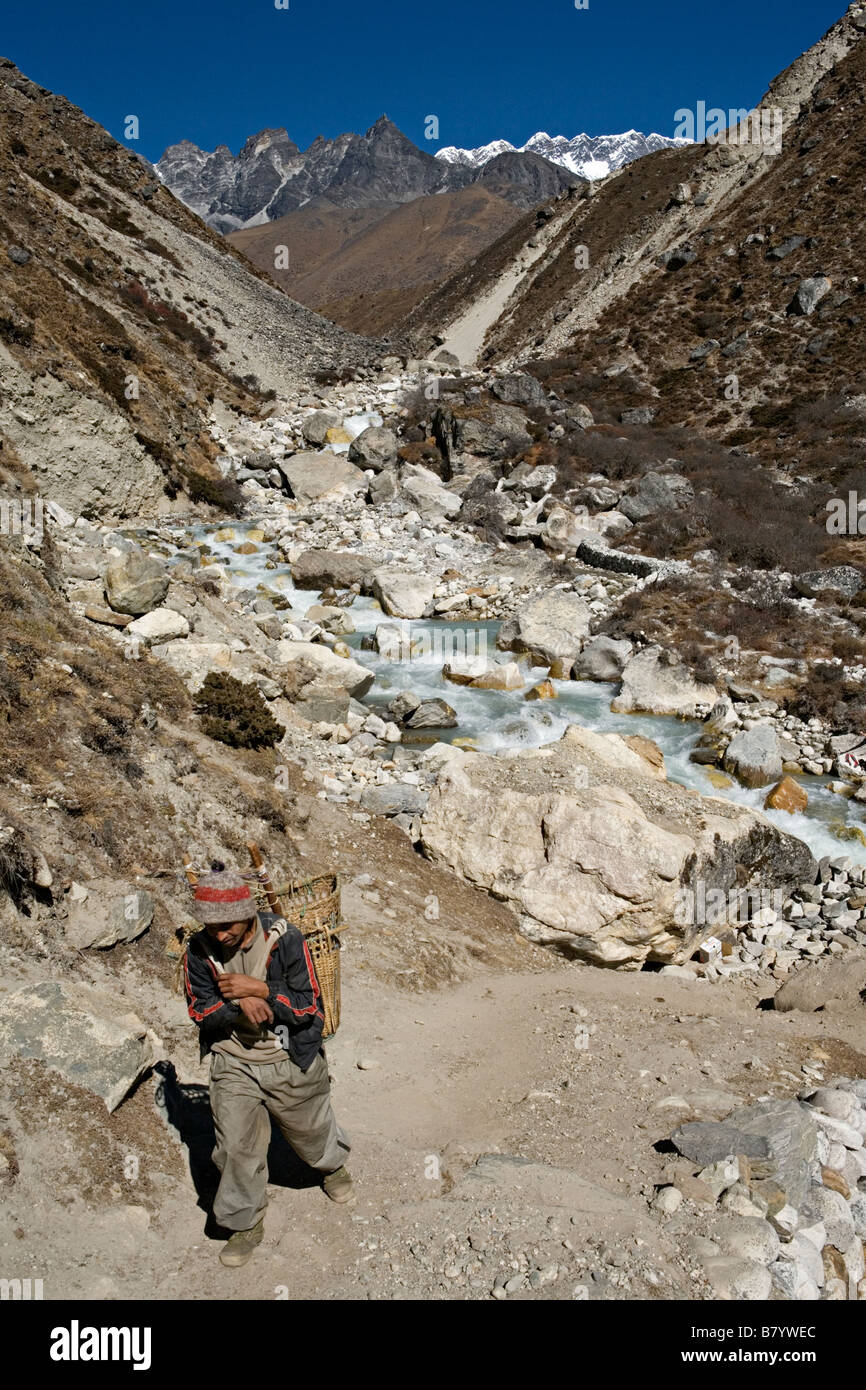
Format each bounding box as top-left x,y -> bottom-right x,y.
0,980 -> 161,1111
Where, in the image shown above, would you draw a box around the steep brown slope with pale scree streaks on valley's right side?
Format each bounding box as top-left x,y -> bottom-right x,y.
410,14 -> 866,478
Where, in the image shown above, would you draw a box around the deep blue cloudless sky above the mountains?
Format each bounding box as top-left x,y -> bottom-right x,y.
0,0 -> 847,158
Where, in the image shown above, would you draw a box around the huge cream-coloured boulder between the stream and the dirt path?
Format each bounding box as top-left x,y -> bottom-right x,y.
421,726 -> 816,970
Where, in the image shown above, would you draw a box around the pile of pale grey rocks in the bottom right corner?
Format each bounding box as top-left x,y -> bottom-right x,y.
652,1077 -> 866,1301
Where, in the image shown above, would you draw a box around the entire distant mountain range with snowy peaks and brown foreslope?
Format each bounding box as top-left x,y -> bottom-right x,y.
156,115 -> 687,332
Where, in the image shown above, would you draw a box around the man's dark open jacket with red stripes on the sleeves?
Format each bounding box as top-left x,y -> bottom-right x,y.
183,912 -> 325,1072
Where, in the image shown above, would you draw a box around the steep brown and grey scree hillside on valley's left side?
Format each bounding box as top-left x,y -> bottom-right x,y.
0,60 -> 374,517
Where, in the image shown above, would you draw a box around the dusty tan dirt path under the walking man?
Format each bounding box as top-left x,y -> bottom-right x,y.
13,958 -> 866,1300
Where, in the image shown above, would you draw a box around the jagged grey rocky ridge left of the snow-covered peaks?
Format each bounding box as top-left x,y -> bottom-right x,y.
156,115 -> 580,232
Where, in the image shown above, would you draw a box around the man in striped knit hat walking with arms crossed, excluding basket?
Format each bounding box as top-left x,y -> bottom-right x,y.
183,863 -> 354,1266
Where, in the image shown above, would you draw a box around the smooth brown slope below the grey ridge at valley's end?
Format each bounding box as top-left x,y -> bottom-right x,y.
228,188 -> 521,334
